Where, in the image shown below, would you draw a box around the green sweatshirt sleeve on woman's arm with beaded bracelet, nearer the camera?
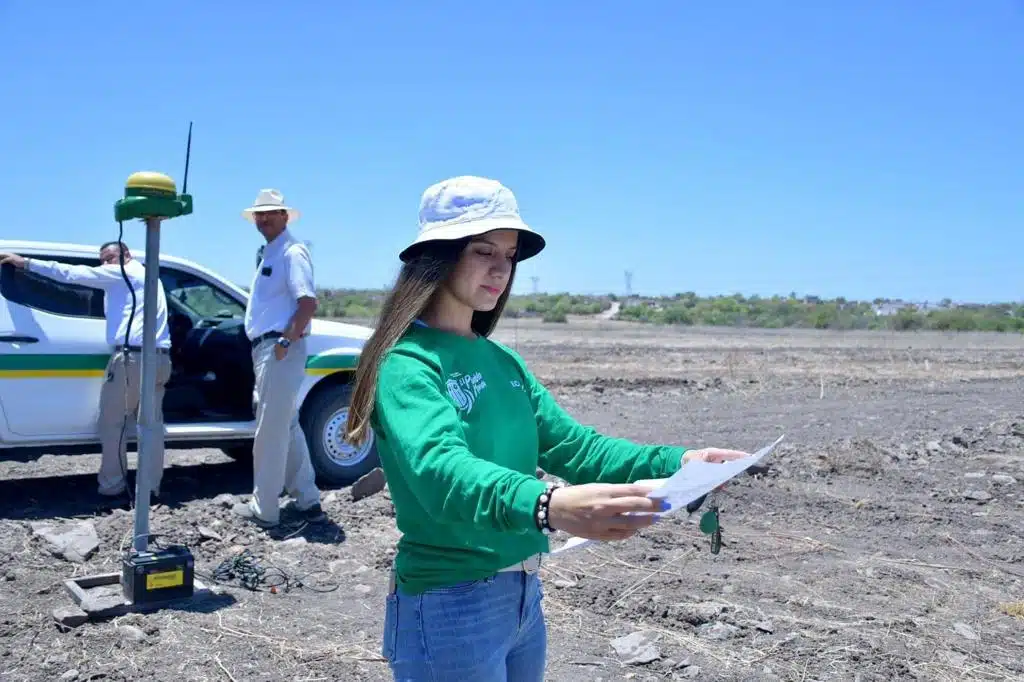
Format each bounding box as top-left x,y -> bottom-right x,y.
374,351 -> 546,532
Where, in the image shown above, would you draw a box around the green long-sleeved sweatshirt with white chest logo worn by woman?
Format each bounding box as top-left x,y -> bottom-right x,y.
372,326 -> 685,594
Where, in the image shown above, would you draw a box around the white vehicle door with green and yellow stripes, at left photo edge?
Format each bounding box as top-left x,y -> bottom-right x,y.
0,254 -> 111,442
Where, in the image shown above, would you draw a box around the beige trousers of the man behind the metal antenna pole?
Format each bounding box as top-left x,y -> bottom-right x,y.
97,352 -> 171,495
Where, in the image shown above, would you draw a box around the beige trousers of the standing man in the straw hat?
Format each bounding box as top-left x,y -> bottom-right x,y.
251,339 -> 319,523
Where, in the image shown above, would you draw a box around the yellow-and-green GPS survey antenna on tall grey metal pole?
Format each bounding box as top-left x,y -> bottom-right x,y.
114,123 -> 193,552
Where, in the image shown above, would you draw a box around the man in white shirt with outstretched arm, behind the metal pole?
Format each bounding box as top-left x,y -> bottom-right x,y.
0,242 -> 171,497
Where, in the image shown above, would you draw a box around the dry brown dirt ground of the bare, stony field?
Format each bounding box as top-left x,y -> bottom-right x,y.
0,319 -> 1024,682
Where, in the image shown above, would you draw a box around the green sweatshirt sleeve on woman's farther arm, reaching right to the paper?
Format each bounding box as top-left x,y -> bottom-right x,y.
509,351 -> 687,484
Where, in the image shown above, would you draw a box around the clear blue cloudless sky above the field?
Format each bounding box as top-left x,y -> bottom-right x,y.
0,0 -> 1024,301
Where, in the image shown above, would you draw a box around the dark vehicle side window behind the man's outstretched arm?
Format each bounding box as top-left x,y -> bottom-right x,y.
0,256 -> 104,319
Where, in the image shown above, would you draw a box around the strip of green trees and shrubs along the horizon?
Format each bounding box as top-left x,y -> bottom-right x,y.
309,289 -> 1024,332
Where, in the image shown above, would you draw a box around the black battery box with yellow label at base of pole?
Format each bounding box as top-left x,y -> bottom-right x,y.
121,545 -> 196,605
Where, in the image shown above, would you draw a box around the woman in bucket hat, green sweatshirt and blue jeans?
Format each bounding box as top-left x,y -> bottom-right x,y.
348,176 -> 746,682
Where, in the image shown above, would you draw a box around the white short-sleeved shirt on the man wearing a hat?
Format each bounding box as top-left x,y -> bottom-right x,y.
246,229 -> 316,340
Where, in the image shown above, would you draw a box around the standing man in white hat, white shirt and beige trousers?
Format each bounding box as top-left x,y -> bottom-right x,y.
233,189 -> 326,527
